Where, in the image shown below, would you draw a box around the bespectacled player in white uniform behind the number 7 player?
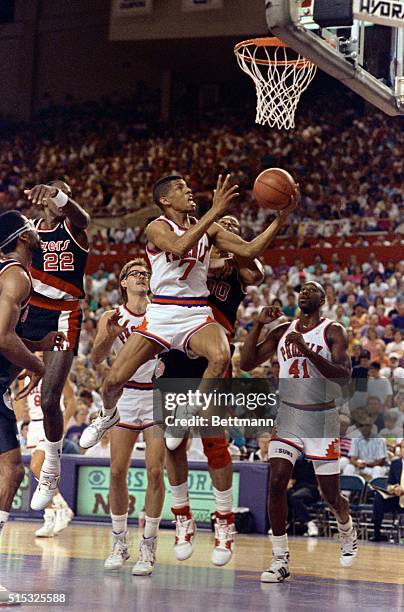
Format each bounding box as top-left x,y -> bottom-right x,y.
92,258 -> 165,576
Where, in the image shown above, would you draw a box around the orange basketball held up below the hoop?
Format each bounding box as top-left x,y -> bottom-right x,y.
254,168 -> 296,210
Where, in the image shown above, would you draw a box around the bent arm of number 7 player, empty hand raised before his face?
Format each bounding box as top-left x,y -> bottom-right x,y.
146,174 -> 239,257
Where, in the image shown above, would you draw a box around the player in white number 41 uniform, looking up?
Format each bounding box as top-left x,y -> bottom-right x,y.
240,282 -> 357,582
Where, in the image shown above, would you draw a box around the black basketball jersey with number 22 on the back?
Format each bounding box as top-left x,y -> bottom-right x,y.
31,219 -> 88,310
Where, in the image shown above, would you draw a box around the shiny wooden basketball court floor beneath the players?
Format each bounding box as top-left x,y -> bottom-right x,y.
0,521 -> 404,612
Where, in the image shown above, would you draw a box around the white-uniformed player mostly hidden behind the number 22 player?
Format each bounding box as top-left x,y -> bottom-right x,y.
13,368 -> 76,538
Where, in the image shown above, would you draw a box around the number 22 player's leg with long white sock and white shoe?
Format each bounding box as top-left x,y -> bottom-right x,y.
31,351 -> 74,510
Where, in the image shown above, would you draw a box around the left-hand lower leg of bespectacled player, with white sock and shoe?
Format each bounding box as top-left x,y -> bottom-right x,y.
104,427 -> 139,570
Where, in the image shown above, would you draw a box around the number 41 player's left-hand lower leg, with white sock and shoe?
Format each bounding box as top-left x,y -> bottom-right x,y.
261,458 -> 293,582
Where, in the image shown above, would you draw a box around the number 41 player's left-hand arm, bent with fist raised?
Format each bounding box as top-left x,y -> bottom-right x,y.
240,306 -> 289,372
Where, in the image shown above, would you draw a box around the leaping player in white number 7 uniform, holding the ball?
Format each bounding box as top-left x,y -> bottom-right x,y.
80,175 -> 297,559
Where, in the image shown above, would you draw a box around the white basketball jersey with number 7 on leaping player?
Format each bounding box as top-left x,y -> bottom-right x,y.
147,215 -> 210,305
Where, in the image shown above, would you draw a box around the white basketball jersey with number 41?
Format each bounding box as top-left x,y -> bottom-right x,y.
277,319 -> 339,405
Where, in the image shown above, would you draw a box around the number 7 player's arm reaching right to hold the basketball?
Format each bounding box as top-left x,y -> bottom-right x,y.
209,191 -> 299,259
